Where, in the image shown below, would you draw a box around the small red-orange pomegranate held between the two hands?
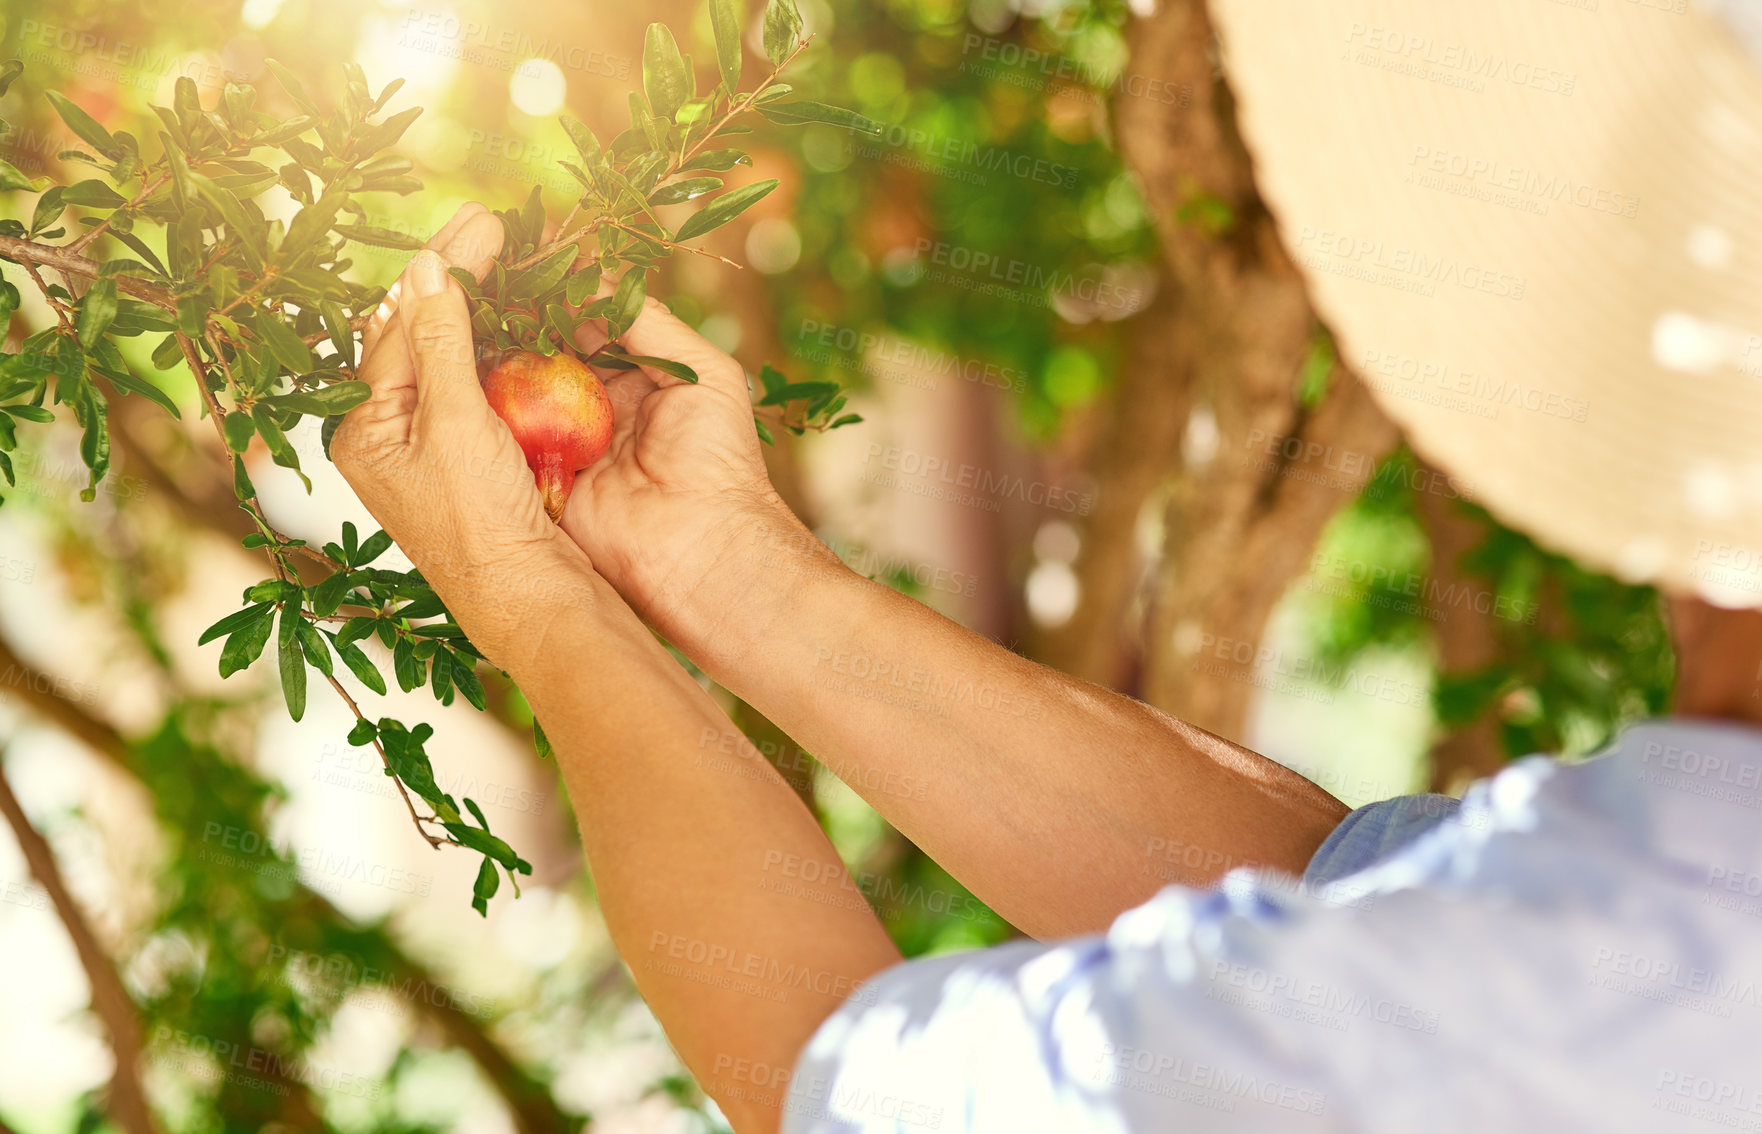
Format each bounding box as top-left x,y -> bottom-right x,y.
483,350 -> 611,523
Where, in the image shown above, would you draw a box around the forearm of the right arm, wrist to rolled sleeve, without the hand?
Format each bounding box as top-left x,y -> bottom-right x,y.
661,500 -> 1346,935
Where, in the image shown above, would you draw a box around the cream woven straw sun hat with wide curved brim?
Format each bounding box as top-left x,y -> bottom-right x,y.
1212,0 -> 1762,606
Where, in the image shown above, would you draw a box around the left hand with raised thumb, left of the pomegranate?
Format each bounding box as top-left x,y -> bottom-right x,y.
331,203 -> 590,667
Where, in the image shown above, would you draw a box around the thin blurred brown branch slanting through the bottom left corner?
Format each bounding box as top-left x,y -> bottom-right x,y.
0,761 -> 159,1134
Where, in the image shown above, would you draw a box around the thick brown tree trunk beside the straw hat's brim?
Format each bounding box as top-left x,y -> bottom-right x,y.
1106,0 -> 1396,740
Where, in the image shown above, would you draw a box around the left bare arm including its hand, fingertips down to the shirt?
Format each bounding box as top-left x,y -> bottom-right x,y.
331,208 -> 899,1134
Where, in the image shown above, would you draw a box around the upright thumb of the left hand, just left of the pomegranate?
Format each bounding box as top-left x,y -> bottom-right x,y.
402,248 -> 488,433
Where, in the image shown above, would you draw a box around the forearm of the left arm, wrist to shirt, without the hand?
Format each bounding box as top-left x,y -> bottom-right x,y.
468,545 -> 899,1134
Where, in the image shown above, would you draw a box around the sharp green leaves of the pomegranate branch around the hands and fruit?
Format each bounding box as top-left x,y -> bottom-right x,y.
0,0 -> 879,912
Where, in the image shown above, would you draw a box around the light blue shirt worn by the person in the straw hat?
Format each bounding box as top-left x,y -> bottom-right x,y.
784,720 -> 1762,1134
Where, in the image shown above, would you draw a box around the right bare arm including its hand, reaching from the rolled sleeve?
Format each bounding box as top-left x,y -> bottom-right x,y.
564,303 -> 1346,935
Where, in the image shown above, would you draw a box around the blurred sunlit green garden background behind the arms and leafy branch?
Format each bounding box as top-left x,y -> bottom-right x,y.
0,0 -> 1672,1134
